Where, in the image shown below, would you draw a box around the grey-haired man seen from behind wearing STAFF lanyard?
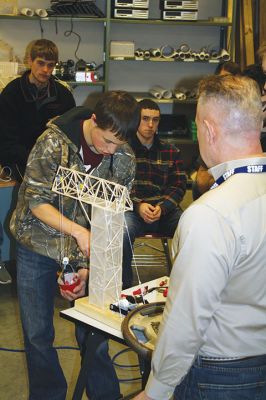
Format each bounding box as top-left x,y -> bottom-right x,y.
135,75 -> 266,400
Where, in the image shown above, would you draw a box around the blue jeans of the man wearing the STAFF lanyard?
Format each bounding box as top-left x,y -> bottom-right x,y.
174,355 -> 266,400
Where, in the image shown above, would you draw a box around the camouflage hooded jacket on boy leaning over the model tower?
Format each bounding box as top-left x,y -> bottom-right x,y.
10,107 -> 135,266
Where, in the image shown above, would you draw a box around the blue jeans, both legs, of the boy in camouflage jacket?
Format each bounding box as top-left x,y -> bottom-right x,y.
17,244 -> 120,400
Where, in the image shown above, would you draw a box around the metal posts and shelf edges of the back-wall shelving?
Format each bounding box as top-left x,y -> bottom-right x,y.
0,0 -> 237,142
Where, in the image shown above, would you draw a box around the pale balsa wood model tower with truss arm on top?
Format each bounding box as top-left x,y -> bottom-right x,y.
52,167 -> 133,310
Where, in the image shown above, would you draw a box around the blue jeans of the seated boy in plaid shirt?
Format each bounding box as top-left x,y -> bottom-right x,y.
122,207 -> 182,289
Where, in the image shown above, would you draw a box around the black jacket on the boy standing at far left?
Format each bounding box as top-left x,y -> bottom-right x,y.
0,71 -> 75,177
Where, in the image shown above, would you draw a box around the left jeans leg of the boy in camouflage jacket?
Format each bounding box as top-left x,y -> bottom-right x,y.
17,244 -> 67,400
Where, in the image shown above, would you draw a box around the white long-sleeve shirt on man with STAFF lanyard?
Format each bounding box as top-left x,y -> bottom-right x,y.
145,153 -> 266,400
